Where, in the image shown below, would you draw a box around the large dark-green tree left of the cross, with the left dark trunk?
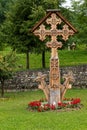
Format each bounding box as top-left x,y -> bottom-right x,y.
3,0 -> 38,68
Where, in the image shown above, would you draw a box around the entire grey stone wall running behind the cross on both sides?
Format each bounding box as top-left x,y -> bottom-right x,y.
1,65 -> 87,90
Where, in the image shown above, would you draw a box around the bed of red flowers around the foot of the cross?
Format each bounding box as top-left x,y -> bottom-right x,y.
28,98 -> 81,112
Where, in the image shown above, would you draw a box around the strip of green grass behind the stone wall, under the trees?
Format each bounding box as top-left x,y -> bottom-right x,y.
0,47 -> 87,70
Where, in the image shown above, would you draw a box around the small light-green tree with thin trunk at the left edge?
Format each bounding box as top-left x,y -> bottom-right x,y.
0,52 -> 16,97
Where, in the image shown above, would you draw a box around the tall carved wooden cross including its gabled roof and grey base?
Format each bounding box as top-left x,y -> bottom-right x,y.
32,10 -> 77,105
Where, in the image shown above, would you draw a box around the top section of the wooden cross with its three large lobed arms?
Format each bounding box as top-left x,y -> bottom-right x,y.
34,13 -> 74,47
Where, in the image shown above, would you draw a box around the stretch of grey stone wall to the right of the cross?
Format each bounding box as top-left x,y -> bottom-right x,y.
61,65 -> 87,88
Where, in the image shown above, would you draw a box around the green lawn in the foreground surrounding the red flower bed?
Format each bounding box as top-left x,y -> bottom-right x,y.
0,89 -> 87,130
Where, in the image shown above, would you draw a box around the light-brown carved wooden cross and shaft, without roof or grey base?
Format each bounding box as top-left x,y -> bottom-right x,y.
34,13 -> 74,88
